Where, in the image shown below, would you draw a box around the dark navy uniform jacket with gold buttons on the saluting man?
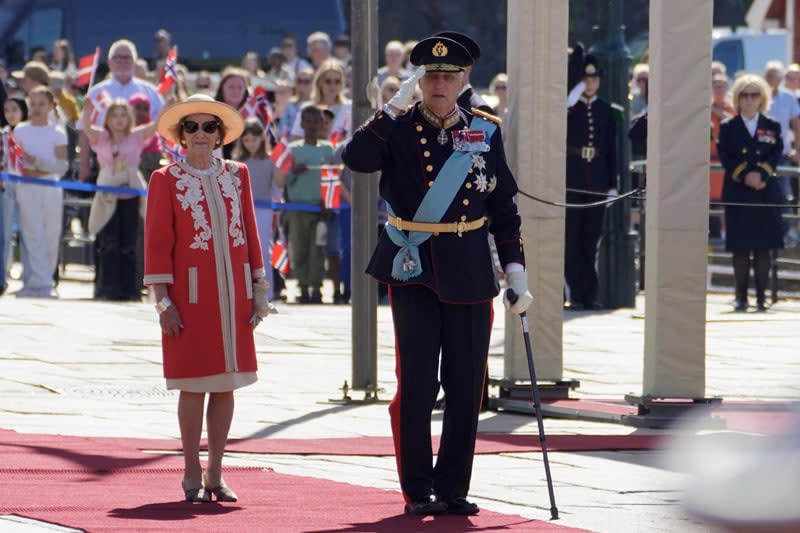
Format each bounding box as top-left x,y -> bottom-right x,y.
342,104 -> 524,303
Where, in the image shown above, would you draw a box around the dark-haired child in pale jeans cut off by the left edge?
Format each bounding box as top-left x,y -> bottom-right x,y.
0,98 -> 30,294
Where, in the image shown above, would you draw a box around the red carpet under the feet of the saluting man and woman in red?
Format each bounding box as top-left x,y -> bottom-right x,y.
0,431 -> 580,533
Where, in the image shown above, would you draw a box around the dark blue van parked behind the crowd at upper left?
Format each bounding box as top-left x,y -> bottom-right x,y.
0,0 -> 347,70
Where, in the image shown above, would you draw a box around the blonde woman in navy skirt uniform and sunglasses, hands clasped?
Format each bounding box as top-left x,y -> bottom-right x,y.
717,74 -> 785,311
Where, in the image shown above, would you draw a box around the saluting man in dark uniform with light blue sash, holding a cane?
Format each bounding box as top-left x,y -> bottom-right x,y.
342,36 -> 532,515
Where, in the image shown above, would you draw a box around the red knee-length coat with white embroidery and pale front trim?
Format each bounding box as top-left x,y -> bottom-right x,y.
144,161 -> 264,379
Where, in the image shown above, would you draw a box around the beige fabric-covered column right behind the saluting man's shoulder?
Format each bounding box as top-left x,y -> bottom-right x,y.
502,0 -> 569,380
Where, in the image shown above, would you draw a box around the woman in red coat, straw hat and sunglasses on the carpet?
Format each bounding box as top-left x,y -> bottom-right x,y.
144,95 -> 268,501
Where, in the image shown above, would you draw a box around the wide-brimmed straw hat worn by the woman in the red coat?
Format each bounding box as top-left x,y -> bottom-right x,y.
156,94 -> 244,144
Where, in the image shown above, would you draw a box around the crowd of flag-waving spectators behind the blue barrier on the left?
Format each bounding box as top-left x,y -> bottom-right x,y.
0,29 -> 507,303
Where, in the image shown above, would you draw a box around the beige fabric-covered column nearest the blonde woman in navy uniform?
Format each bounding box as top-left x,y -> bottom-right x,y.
643,0 -> 713,398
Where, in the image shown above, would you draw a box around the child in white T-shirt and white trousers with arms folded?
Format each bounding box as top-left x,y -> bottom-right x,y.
13,86 -> 68,298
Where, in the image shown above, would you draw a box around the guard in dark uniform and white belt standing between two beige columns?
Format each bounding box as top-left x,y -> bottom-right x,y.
564,55 -> 617,310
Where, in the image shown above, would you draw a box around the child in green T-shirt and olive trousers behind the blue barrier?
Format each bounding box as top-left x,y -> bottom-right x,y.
275,105 -> 333,303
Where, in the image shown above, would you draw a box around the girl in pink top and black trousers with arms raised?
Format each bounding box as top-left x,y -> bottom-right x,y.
83,94 -> 156,302
